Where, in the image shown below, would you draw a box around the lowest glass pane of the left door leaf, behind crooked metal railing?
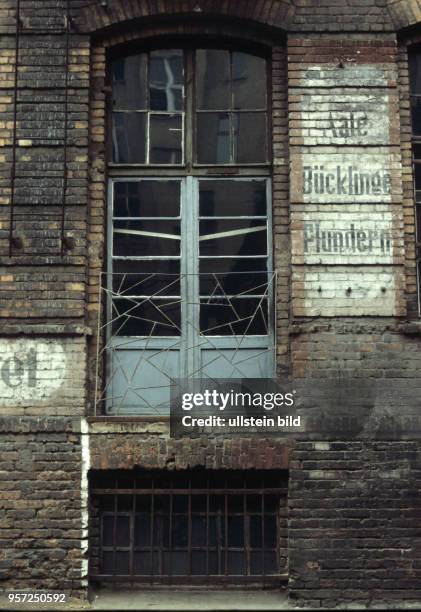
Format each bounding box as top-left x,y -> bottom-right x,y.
112,298 -> 180,336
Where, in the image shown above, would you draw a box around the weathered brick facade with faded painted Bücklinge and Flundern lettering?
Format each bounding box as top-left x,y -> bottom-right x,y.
0,0 -> 421,606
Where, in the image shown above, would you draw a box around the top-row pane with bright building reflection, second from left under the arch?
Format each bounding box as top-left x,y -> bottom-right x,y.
149,49 -> 184,111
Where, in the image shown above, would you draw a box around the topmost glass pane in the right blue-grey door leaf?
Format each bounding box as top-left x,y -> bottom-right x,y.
199,180 -> 266,217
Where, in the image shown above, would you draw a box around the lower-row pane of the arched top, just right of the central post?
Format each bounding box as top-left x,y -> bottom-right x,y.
196,113 -> 231,164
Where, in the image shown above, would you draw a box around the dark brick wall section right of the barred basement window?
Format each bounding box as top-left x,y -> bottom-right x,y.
289,441 -> 421,607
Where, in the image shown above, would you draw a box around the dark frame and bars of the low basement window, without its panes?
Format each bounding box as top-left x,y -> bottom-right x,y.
90,470 -> 288,587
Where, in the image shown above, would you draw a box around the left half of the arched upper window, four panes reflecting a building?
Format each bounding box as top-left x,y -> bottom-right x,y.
111,49 -> 184,165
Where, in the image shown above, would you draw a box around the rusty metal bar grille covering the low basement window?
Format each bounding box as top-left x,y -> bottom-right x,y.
88,471 -> 287,585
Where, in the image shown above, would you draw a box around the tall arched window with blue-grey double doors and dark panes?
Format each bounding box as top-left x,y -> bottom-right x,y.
105,48 -> 275,414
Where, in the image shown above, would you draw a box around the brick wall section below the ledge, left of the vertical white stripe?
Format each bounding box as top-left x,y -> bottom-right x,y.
0,417 -> 83,605
